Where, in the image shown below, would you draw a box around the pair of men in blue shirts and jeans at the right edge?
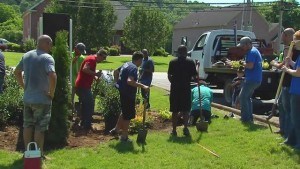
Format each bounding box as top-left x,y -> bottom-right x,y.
271,28 -> 300,151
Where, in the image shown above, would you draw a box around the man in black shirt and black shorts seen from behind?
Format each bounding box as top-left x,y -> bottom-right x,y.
168,45 -> 197,136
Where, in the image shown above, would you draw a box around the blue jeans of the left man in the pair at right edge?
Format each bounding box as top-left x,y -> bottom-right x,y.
278,87 -> 291,138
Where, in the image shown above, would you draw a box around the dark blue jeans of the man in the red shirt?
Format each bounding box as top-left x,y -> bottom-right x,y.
76,88 -> 94,129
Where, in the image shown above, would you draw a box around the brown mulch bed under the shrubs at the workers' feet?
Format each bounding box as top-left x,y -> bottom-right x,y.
0,112 -> 172,151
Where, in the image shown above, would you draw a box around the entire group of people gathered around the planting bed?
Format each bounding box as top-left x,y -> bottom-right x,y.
8,28 -> 300,158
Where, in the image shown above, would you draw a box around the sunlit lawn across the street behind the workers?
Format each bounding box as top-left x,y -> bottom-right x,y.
3,52 -> 173,72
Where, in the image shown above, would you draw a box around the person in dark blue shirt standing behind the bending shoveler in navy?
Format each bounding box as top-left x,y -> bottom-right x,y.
139,49 -> 154,109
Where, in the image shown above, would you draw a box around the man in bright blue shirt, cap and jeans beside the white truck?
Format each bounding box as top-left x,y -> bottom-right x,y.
238,37 -> 262,122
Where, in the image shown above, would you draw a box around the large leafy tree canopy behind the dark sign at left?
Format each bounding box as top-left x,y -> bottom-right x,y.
47,0 -> 116,48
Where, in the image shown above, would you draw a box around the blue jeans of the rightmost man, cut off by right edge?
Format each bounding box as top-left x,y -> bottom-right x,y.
286,94 -> 300,150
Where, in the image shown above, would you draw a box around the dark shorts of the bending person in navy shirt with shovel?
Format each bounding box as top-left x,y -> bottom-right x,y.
120,94 -> 135,120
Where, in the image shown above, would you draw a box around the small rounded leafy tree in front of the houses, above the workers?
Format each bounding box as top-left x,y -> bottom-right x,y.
123,7 -> 171,54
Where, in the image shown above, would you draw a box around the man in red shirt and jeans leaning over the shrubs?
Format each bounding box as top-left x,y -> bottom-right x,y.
75,49 -> 107,131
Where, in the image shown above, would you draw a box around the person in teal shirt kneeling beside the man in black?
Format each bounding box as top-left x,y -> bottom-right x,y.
189,81 -> 213,125
